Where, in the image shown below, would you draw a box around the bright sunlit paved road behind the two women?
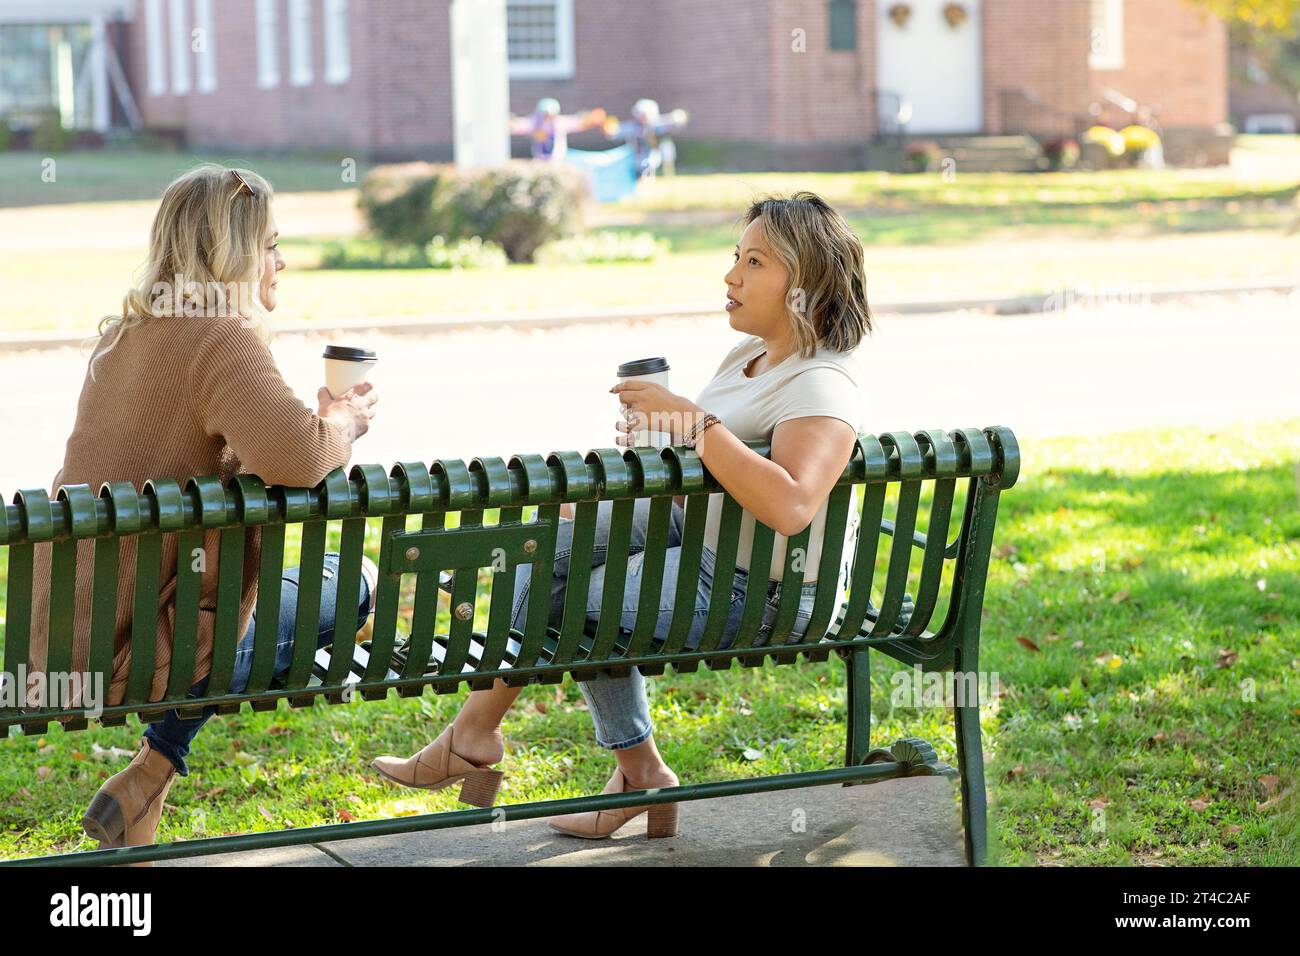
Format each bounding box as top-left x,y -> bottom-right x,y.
0,293 -> 1300,489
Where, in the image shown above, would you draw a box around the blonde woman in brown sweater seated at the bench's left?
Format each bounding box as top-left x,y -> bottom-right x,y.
31,165 -> 377,847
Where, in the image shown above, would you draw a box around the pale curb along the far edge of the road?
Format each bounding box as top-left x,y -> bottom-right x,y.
0,278 -> 1300,351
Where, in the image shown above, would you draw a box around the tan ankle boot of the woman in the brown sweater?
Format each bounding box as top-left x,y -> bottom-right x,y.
82,739 -> 176,866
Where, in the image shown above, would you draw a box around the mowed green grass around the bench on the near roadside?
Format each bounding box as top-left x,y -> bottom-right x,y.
0,420 -> 1300,865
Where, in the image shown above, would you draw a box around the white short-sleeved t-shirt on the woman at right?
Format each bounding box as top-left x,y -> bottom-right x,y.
696,336 -> 866,590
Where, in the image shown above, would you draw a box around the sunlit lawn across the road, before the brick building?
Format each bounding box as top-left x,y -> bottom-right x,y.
0,145 -> 1300,334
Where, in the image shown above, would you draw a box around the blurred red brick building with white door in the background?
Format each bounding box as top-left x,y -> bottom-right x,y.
0,0 -> 1229,168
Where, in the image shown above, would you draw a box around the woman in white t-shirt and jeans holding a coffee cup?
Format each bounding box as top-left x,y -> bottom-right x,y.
374,193 -> 871,838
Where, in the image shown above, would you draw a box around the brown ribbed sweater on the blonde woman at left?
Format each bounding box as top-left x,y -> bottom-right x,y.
29,317 -> 351,706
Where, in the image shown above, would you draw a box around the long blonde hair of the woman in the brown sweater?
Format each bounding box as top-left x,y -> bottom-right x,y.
90,163 -> 273,378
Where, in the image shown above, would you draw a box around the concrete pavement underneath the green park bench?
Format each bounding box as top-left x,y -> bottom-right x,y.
159,777 -> 965,866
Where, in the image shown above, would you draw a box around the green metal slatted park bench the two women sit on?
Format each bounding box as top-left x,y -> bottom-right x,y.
0,428 -> 1019,865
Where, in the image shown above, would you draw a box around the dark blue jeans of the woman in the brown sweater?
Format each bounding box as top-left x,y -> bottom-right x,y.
144,551 -> 371,777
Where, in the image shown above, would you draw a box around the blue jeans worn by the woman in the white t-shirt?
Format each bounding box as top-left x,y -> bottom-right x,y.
512,498 -> 816,750
